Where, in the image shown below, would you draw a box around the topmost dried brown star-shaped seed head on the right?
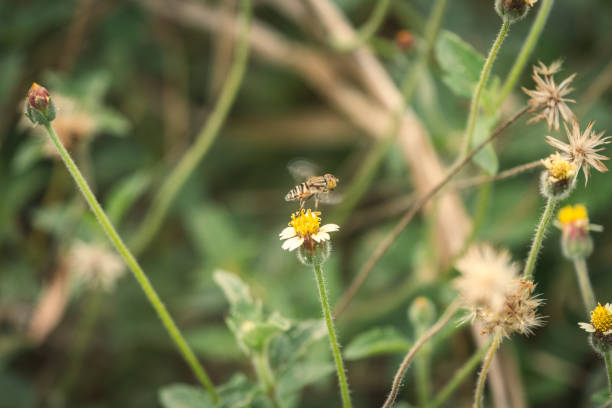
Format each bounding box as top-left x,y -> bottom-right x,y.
523,61 -> 576,131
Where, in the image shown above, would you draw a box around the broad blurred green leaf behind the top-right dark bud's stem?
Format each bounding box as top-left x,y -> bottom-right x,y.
436,31 -> 485,98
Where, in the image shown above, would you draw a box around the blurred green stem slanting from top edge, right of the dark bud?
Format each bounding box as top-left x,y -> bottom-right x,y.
493,0 -> 554,112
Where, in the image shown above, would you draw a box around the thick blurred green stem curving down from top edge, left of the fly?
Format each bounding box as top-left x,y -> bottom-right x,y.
131,0 -> 251,254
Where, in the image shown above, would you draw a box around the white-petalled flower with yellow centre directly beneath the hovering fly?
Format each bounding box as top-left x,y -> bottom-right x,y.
279,210 -> 340,251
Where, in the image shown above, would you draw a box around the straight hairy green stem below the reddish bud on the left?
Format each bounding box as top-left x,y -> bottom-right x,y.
45,123 -> 219,403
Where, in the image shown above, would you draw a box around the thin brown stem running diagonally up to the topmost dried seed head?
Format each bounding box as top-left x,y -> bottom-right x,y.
335,106 -> 529,316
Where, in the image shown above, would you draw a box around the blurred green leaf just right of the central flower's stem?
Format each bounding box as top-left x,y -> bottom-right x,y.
344,327 -> 410,360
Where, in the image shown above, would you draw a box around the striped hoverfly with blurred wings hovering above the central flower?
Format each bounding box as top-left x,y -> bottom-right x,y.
285,160 -> 340,209
